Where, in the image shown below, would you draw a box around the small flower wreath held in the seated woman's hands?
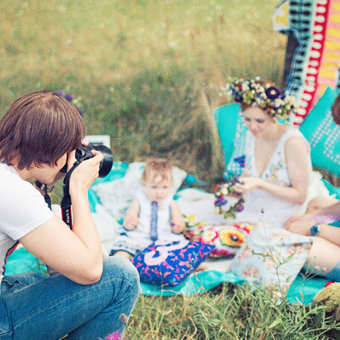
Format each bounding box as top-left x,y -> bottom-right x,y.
214,177 -> 244,219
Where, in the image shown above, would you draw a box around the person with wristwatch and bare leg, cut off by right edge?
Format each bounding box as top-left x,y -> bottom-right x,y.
285,95 -> 340,281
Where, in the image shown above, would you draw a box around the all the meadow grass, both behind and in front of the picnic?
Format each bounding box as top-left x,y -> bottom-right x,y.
0,0 -> 340,339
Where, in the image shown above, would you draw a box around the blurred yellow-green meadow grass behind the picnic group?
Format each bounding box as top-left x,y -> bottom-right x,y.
0,0 -> 286,179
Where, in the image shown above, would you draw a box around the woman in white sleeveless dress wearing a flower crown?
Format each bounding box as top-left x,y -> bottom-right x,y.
219,79 -> 312,228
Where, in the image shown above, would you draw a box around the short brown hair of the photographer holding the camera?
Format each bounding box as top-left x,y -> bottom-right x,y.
0,90 -> 86,170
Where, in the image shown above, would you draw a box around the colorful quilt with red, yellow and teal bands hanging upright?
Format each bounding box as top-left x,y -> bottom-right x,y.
274,0 -> 340,125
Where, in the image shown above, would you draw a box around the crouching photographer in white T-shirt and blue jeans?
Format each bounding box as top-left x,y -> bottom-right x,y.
0,91 -> 139,340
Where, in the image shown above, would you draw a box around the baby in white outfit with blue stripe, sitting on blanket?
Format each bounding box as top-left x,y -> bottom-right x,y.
111,158 -> 185,259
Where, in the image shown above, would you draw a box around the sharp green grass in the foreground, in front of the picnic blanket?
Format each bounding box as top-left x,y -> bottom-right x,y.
127,283 -> 340,340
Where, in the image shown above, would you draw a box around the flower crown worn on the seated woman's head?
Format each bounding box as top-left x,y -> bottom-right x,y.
222,77 -> 297,119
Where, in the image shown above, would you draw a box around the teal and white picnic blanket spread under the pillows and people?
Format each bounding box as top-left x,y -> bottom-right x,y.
6,162 -> 338,304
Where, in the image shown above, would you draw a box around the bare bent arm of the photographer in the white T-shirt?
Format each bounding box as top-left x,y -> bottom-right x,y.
20,154 -> 103,284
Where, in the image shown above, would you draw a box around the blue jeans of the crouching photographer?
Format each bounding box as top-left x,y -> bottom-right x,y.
0,256 -> 139,340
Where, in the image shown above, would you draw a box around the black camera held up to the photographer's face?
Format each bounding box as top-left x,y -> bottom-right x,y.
60,144 -> 113,178
